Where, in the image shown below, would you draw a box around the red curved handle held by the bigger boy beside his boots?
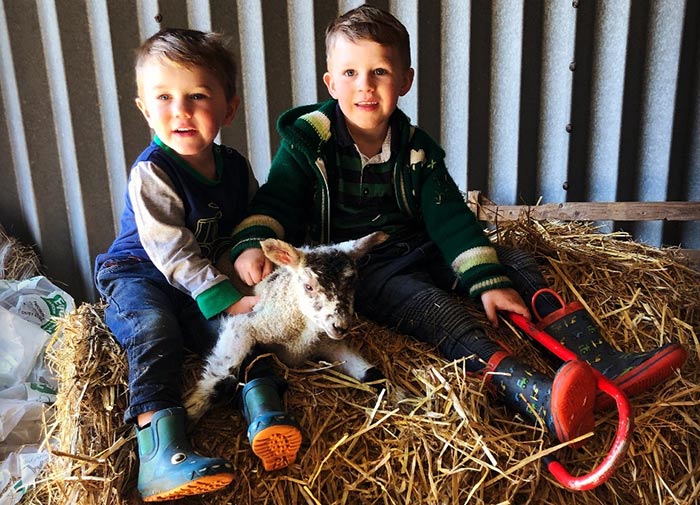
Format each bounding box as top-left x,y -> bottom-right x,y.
508,312 -> 633,491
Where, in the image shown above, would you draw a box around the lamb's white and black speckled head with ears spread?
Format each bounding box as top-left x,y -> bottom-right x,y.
260,232 -> 388,340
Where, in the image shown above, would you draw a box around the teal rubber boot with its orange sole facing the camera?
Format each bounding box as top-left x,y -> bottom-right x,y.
241,377 -> 302,471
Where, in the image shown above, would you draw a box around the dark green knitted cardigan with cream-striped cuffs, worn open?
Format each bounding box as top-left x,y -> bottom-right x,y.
231,100 -> 512,297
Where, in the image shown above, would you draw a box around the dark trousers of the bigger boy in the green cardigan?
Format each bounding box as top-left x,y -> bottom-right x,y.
355,237 -> 558,372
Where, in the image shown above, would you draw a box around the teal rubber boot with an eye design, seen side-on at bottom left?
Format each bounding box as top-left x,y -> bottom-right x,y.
136,408 -> 233,502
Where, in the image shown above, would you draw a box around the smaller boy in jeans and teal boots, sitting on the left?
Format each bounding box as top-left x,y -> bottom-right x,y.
95,29 -> 301,501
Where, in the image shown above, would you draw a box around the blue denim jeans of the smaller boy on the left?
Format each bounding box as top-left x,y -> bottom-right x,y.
95,258 -> 272,422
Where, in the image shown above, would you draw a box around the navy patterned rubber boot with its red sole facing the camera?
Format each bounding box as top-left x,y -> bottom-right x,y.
486,351 -> 597,447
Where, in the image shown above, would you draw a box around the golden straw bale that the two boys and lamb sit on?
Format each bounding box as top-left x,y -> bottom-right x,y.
21,221 -> 700,505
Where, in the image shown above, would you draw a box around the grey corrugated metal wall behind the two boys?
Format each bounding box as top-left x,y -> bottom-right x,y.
0,0 -> 700,300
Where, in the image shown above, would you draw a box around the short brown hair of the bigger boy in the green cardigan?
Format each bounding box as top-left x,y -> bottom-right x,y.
326,4 -> 411,70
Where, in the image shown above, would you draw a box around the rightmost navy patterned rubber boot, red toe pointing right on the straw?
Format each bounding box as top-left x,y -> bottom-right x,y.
536,290 -> 688,410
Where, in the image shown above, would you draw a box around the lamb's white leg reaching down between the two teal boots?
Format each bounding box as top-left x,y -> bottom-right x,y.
185,316 -> 255,422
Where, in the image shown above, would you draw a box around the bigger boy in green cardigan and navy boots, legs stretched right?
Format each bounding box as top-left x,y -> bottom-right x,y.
231,5 -> 686,448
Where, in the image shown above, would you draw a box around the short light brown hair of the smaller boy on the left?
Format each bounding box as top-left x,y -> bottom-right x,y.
136,28 -> 238,100
